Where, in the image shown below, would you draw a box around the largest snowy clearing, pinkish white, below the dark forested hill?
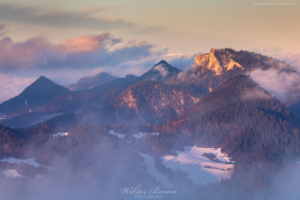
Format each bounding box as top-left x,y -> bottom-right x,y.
162,146 -> 234,184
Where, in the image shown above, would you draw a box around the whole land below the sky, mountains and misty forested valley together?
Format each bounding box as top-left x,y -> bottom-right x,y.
0,48 -> 300,199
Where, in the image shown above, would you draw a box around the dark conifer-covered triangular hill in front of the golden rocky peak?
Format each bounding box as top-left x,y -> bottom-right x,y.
158,75 -> 300,159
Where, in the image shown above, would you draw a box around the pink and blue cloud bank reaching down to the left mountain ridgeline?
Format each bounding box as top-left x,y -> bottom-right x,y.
0,32 -> 164,102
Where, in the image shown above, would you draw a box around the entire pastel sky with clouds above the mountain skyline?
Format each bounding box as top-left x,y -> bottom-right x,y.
0,0 -> 300,102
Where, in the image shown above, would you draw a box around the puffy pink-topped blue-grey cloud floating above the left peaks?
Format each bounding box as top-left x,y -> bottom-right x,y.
0,33 -> 158,71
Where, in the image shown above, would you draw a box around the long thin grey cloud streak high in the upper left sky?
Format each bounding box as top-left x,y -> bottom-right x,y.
0,3 -> 134,30
